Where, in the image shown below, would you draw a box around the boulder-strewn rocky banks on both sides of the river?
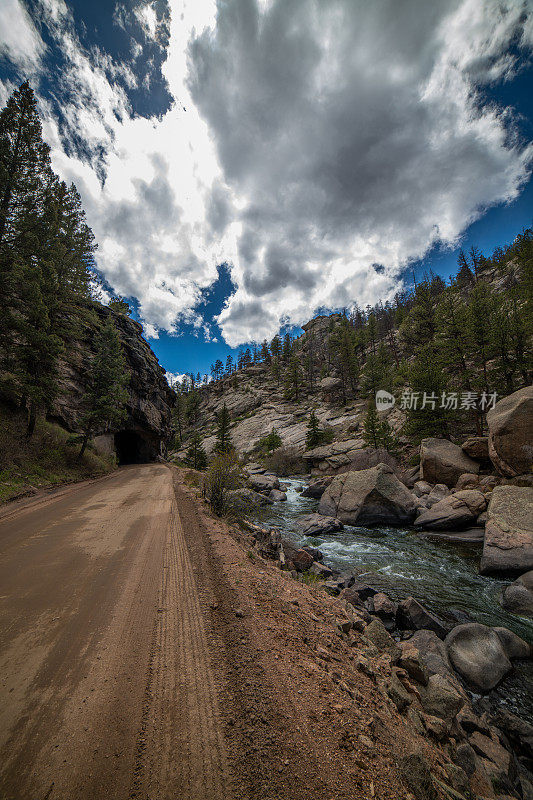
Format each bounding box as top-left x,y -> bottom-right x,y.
230,387 -> 533,798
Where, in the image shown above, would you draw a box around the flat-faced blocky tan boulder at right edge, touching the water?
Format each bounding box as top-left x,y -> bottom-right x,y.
480,486 -> 533,575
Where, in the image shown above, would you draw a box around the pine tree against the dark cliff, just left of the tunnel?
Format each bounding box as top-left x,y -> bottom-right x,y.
79,321 -> 129,458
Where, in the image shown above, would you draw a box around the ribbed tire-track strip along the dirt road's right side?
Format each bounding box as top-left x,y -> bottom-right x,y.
130,494 -> 230,800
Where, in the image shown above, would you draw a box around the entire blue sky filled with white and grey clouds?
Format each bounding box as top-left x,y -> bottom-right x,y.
0,0 -> 533,372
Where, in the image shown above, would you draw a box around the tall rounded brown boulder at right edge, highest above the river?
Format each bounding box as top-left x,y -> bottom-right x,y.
487,386 -> 533,477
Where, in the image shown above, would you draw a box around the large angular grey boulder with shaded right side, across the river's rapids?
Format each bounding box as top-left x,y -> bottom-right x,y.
318,464 -> 416,525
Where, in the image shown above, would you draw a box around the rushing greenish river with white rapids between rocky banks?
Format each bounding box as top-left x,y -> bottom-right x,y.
261,478 -> 533,718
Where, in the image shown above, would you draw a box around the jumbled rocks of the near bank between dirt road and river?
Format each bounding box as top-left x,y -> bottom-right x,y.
242,515 -> 533,798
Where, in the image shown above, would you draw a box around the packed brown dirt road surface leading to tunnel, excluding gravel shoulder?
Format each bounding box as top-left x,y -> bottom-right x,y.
0,465 -> 229,800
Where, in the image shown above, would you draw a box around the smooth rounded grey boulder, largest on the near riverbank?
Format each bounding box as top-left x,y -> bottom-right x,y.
445,622 -> 530,692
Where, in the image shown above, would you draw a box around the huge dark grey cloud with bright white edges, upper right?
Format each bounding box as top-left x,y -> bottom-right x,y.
189,0 -> 531,341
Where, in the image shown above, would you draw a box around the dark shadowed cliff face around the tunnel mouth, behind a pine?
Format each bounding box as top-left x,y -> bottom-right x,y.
50,302 -> 174,464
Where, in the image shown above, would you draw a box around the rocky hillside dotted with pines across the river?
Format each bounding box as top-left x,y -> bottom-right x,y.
175,229 -> 533,462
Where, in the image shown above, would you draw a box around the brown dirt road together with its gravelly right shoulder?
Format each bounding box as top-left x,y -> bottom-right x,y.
0,464 -> 434,800
